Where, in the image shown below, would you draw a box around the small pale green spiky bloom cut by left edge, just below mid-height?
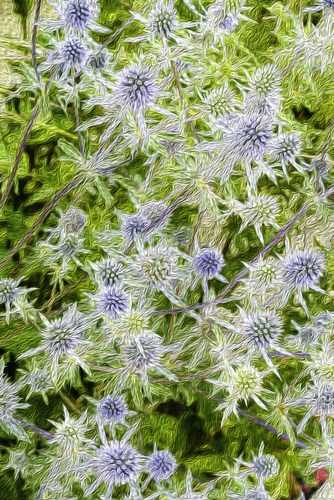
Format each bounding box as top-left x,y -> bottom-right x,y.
0,278 -> 36,323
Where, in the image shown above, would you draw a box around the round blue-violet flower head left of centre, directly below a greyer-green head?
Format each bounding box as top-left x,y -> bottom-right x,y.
94,286 -> 129,319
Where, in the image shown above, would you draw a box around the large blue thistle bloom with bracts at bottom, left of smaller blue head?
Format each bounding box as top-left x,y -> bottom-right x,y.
82,436 -> 144,498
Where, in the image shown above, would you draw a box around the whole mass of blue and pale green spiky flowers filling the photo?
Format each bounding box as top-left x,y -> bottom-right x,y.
0,0 -> 334,500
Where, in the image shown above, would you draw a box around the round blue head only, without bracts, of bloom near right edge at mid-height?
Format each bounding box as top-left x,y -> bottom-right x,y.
284,249 -> 325,291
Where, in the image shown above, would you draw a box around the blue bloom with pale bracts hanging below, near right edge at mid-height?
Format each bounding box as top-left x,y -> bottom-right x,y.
282,249 -> 325,314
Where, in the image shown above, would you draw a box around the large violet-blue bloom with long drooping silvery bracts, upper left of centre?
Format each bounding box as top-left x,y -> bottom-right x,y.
81,63 -> 171,142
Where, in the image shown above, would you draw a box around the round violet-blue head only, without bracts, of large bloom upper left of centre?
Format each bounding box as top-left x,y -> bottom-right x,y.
116,64 -> 158,112
